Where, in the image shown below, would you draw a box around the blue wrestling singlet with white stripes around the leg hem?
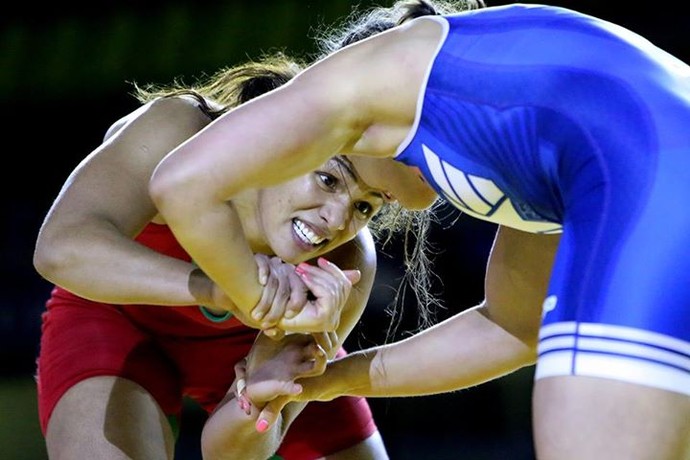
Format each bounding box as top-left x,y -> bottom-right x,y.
396,4 -> 690,395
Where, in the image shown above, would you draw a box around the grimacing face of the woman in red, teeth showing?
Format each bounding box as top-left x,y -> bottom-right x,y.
250,156 -> 385,263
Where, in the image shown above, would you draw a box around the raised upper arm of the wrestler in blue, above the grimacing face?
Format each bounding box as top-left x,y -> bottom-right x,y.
151,38 -> 404,208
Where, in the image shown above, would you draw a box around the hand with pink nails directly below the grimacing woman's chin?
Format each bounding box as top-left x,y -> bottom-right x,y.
280,257 -> 361,333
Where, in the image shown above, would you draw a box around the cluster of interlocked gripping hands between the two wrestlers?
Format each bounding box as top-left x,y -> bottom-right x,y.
232,255 -> 360,432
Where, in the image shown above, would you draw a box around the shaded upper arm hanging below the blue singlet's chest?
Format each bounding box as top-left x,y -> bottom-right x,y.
484,227 -> 560,346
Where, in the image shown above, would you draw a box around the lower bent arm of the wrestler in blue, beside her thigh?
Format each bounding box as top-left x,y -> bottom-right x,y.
292,228 -> 559,400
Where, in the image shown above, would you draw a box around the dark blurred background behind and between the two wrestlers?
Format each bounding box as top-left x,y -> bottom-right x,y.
0,0 -> 690,460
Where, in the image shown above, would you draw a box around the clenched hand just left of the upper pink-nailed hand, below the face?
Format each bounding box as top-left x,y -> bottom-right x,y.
251,254 -> 308,339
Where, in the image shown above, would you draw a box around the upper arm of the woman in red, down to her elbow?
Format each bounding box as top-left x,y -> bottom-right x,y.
34,99 -> 208,274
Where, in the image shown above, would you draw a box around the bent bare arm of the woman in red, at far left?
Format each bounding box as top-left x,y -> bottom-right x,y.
34,99 -> 222,306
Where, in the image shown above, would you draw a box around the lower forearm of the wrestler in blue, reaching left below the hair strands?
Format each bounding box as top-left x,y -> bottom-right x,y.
305,308 -> 535,400
